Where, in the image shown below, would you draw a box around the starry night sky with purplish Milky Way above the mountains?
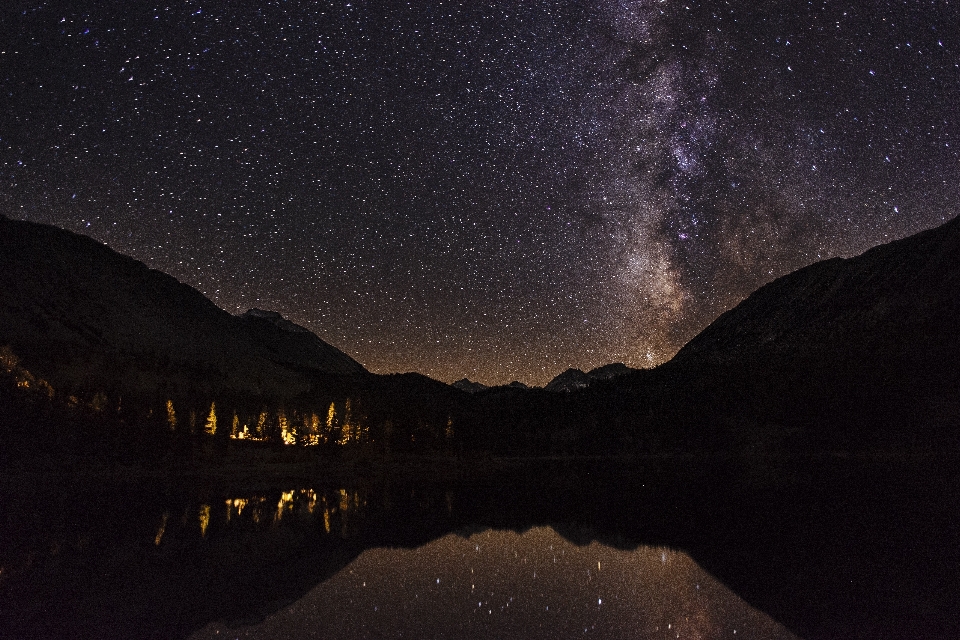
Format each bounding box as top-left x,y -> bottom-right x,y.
0,0 -> 960,384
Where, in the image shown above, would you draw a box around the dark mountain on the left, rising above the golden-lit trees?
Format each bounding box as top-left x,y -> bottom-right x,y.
0,218 -> 365,398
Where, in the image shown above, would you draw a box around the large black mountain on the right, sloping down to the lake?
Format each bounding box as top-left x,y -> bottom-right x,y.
623,218 -> 960,453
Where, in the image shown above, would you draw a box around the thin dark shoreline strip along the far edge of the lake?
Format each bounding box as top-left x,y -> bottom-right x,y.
0,451 -> 960,492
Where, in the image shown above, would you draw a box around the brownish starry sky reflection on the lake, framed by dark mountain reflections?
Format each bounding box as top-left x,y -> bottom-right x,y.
191,527 -> 795,640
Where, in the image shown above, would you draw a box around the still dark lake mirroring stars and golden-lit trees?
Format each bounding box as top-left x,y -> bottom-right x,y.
0,459 -> 960,638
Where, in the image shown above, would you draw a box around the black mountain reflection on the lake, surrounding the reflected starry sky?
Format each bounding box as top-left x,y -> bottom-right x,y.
0,458 -> 960,638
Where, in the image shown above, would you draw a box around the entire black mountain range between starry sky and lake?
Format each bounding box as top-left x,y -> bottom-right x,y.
0,218 -> 960,455
